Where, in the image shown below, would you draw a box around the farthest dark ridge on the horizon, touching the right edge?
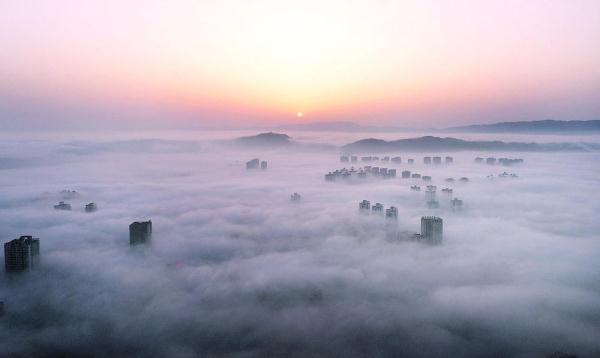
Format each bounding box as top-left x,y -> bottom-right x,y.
444,120 -> 600,133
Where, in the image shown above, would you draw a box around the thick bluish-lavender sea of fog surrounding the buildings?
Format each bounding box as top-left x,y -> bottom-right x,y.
0,131 -> 600,357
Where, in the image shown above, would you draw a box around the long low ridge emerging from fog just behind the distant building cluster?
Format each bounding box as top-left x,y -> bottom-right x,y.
342,136 -> 600,152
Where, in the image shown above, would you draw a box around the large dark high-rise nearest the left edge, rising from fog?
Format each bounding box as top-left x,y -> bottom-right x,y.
4,236 -> 40,272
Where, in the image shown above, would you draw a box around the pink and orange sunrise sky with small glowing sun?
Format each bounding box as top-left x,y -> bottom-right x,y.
0,0 -> 600,130
